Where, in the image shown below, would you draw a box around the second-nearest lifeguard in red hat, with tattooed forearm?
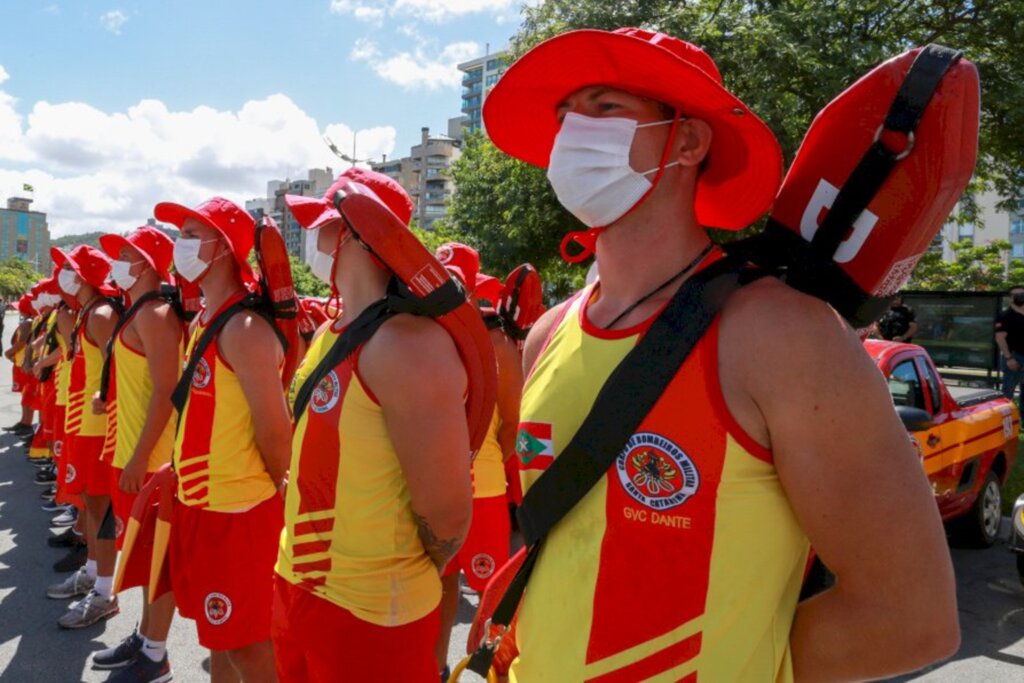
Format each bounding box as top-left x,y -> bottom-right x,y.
274,168 -> 482,682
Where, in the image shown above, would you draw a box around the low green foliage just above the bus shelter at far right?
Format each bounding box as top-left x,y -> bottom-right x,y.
904,240 -> 1024,292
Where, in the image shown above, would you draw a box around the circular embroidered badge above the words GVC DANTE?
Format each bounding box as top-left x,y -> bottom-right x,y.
615,432 -> 700,510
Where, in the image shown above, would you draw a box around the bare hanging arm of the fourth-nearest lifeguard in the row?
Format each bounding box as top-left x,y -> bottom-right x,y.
119,303 -> 181,494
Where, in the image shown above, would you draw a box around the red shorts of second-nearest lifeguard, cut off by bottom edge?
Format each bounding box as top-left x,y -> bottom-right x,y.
273,577 -> 440,683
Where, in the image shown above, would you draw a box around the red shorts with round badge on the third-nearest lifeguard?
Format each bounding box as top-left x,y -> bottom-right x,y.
169,496 -> 285,650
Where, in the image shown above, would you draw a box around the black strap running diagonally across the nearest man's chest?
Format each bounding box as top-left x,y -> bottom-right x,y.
468,258 -> 742,677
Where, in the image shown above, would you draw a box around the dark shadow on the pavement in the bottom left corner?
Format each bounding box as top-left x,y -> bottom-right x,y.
0,432 -> 116,683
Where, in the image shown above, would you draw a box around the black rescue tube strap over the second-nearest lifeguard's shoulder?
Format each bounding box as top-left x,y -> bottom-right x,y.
292,278 -> 466,422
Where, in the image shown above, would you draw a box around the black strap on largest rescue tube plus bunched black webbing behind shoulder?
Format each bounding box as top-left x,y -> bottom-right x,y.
725,44 -> 963,328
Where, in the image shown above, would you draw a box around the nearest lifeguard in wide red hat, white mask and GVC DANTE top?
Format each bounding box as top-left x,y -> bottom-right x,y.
483,29 -> 958,681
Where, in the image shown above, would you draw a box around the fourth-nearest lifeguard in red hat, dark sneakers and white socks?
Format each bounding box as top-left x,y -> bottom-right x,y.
84,225 -> 183,681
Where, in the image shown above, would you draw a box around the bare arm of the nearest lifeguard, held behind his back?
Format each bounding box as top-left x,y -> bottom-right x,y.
720,282 -> 959,681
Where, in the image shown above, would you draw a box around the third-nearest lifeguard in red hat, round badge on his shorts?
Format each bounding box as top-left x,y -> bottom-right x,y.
155,198 -> 291,681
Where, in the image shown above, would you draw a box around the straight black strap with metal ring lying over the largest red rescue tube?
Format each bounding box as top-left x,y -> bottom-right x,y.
811,45 -> 962,259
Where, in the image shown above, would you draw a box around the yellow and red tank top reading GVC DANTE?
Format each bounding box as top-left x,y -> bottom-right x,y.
512,287 -> 809,682
